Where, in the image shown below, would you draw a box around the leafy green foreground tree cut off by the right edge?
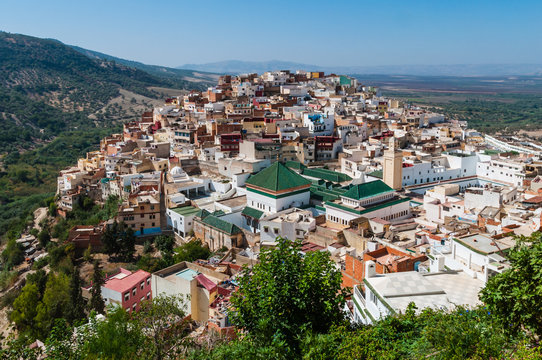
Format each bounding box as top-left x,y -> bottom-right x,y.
480,232 -> 542,337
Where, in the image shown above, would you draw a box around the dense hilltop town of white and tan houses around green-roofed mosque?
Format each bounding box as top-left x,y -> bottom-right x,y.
57,71 -> 542,331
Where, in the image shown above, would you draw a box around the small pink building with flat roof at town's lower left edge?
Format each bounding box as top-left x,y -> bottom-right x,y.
102,268 -> 152,312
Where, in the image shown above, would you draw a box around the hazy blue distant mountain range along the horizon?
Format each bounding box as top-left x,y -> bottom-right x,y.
178,60 -> 542,76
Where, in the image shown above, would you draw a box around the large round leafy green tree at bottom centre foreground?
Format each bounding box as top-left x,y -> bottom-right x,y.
230,238 -> 346,350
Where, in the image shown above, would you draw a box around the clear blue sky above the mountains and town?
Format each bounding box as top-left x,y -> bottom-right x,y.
0,0 -> 542,66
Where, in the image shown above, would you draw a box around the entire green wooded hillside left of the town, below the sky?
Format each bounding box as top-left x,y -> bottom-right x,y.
0,32 -> 211,237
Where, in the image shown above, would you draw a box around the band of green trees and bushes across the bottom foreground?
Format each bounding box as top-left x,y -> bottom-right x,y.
0,233 -> 542,360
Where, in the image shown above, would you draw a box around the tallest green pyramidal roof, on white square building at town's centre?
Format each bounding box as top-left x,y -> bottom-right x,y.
246,161 -> 311,191
